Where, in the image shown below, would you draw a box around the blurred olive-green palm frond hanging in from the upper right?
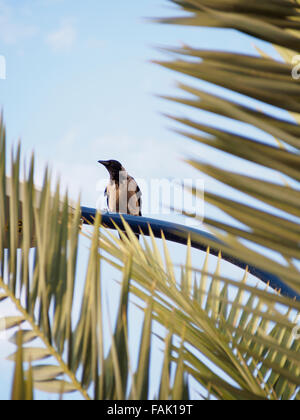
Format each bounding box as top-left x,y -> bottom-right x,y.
157,0 -> 300,291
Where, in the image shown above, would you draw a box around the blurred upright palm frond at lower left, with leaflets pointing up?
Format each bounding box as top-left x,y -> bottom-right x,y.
0,115 -> 192,400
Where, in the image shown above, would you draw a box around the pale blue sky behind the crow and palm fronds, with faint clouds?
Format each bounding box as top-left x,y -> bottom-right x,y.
0,0 -> 290,398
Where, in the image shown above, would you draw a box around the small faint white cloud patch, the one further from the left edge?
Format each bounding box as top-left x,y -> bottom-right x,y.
46,19 -> 77,52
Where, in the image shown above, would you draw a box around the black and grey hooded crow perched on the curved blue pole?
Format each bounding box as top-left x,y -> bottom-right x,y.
98,160 -> 142,238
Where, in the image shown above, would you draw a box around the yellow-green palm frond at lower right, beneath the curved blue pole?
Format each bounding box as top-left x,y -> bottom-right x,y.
95,226 -> 300,399
